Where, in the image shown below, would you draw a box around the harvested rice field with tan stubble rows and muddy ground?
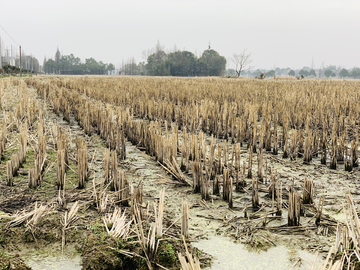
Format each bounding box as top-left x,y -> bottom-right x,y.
0,76 -> 360,270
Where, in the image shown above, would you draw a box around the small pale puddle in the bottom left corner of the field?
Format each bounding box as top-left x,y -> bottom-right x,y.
21,249 -> 82,270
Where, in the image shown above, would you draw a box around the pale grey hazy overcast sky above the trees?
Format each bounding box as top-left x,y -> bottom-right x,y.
0,0 -> 360,69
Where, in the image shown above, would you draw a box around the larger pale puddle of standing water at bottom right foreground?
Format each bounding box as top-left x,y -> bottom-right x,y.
192,236 -> 321,270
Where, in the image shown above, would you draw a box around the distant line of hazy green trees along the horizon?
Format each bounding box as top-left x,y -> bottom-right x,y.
1,42 -> 360,79
